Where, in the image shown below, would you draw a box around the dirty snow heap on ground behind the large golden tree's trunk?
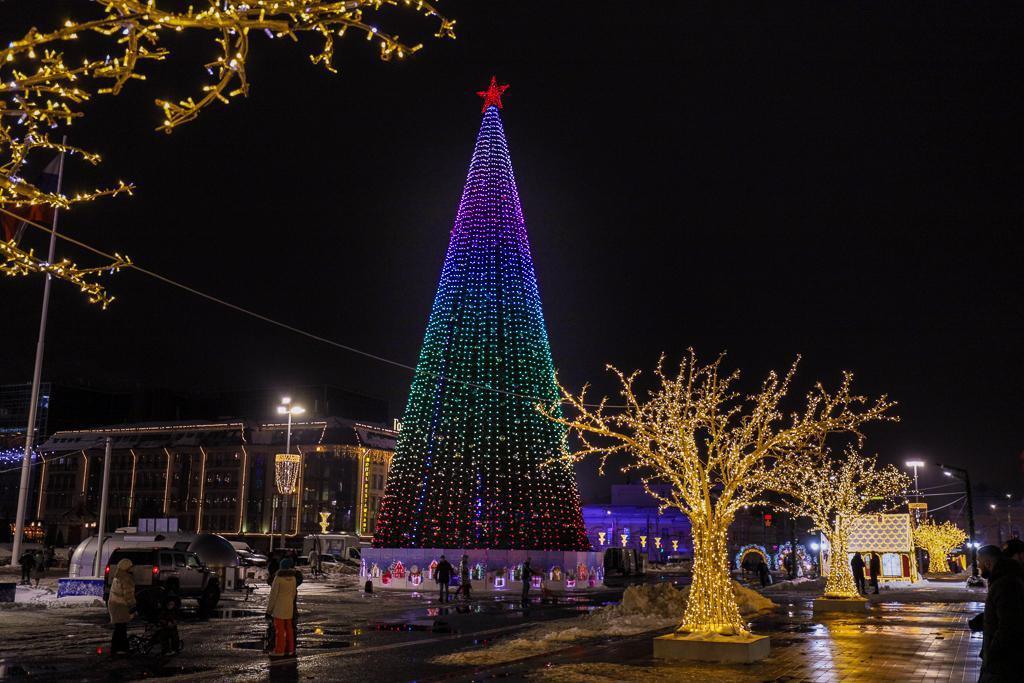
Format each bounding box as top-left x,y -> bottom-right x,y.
431,582 -> 775,666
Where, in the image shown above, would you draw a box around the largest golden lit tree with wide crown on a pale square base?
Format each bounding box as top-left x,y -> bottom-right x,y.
540,350 -> 893,635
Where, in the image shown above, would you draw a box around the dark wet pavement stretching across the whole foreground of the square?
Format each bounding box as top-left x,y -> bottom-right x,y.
0,581 -> 981,683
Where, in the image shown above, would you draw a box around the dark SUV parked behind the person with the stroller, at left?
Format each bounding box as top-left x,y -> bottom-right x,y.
103,548 -> 220,609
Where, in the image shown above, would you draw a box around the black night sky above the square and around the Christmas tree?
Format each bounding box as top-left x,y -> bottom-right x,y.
0,0 -> 1024,499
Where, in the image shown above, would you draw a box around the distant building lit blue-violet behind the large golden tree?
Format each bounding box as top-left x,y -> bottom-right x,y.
583,484 -> 693,562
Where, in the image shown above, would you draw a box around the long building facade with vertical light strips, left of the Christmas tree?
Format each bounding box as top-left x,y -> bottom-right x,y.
29,418 -> 397,548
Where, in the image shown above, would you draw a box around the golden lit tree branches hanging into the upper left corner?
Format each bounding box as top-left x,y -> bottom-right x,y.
0,0 -> 455,296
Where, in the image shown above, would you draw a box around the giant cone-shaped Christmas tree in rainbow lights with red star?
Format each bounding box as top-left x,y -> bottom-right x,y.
374,79 -> 590,550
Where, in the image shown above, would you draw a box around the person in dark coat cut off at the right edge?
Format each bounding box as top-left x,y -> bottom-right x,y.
978,546 -> 1024,683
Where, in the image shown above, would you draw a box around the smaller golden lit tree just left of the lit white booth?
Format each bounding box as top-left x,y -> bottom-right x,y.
769,445 -> 910,598
